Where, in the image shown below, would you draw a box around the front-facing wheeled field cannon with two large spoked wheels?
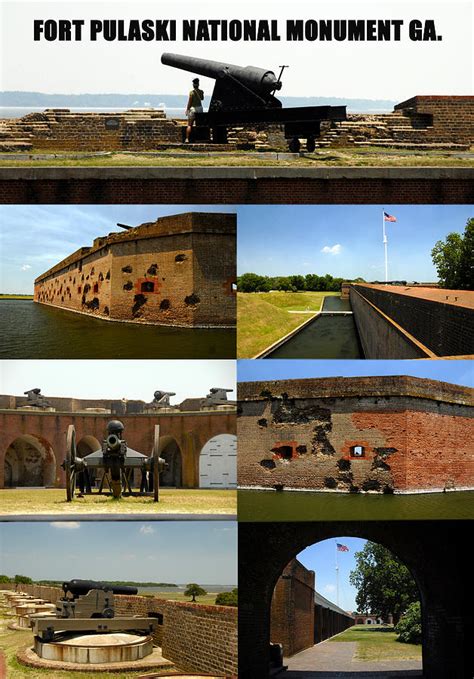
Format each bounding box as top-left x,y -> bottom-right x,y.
61,420 -> 168,502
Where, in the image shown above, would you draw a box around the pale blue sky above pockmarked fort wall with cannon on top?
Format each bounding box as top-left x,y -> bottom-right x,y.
0,205 -> 235,294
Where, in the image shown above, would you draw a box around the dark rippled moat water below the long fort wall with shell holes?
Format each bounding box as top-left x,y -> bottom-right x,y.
0,300 -> 236,358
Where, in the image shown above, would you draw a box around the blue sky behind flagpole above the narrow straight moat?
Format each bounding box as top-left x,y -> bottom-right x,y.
237,204 -> 474,282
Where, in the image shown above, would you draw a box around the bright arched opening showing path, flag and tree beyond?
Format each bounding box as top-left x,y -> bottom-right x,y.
270,540 -> 422,679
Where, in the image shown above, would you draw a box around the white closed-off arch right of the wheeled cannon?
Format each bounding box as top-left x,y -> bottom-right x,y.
199,434 -> 237,488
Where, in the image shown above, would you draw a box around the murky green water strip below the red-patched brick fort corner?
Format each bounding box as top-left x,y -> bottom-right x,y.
237,490 -> 474,521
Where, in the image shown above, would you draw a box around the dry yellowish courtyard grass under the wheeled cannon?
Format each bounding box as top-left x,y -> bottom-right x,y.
0,488 -> 237,515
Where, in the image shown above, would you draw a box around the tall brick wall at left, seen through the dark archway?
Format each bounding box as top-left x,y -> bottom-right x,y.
270,559 -> 315,656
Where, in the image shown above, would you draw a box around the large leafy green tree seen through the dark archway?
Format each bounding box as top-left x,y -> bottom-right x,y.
349,542 -> 418,625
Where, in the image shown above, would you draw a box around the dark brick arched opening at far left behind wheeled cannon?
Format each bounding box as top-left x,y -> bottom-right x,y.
4,434 -> 56,488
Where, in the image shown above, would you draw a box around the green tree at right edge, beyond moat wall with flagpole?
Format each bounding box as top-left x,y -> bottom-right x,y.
431,218 -> 474,290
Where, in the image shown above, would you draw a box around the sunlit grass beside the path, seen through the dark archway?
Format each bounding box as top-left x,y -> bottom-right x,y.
329,625 -> 421,661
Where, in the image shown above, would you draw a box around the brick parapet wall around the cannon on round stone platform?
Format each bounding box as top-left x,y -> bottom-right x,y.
2,585 -> 237,677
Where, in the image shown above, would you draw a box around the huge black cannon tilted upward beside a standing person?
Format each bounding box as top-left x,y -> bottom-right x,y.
161,53 -> 346,153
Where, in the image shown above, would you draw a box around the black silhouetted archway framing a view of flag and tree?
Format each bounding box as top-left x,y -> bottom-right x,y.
239,521 -> 473,679
